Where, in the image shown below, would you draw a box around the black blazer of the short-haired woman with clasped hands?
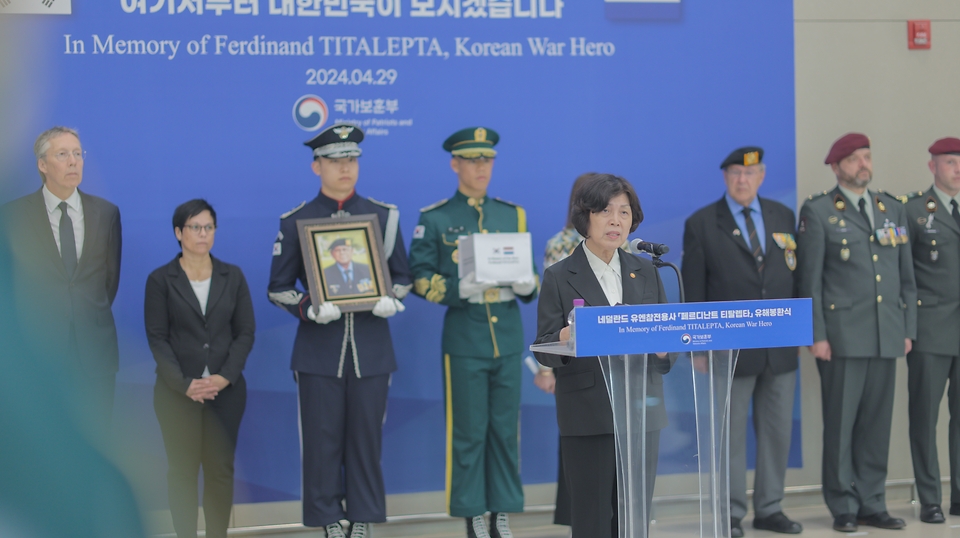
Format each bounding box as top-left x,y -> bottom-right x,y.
143,255 -> 256,394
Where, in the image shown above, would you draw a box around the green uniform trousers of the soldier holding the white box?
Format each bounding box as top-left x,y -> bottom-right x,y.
443,353 -> 523,517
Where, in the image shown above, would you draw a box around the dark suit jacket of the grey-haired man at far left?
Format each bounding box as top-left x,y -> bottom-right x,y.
0,190 -> 121,375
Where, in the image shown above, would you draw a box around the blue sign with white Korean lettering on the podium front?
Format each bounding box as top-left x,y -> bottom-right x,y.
576,299 -> 813,357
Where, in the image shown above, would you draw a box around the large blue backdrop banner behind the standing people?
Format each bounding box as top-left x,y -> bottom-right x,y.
0,0 -> 799,502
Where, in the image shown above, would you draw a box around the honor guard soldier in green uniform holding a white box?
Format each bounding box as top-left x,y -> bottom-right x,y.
410,127 -> 539,538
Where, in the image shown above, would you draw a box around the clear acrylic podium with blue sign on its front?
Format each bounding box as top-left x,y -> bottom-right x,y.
530,299 -> 813,538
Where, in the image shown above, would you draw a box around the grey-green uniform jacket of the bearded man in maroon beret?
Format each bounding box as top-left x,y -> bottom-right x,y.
796,187 -> 917,358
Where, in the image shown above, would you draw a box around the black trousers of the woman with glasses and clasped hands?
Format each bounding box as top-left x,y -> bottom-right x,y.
153,376 -> 247,538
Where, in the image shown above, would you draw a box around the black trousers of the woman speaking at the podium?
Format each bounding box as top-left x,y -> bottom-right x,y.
560,430 -> 660,538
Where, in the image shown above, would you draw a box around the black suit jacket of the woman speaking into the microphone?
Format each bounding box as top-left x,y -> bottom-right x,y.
535,243 -> 676,435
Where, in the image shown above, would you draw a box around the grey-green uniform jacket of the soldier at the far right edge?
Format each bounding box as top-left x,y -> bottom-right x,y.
905,187 -> 960,356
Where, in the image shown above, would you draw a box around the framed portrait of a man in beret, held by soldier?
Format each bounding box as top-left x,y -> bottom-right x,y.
297,213 -> 393,312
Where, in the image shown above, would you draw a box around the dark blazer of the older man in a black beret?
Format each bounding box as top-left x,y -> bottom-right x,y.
681,197 -> 797,376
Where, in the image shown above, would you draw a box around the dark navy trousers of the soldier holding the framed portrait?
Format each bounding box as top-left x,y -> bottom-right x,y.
297,368 -> 390,527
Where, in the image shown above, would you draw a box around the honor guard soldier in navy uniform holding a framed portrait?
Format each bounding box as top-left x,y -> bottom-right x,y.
268,124 -> 411,538
